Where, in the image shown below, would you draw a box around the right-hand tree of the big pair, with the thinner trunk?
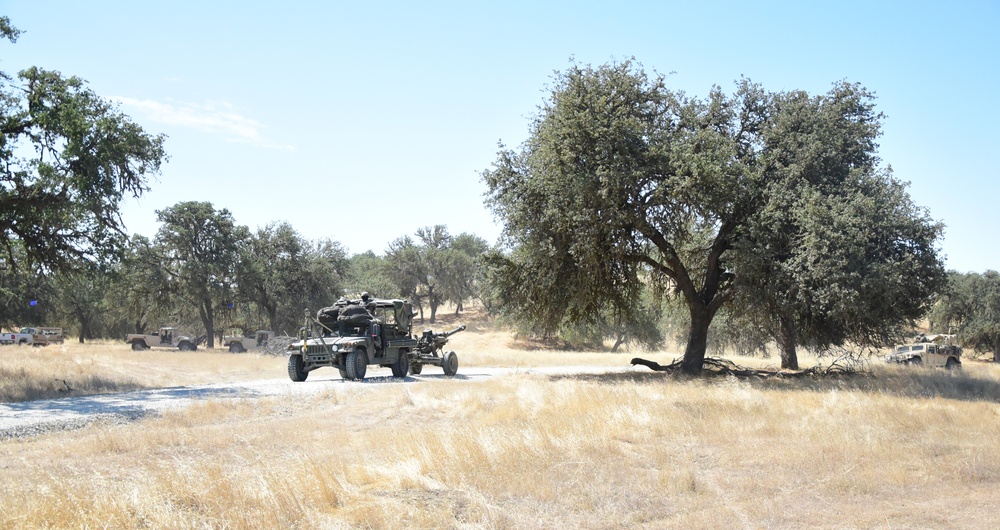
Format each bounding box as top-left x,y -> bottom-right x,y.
730,83 -> 944,368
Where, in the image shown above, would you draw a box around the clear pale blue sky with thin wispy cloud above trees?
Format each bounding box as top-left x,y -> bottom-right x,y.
0,0 -> 1000,272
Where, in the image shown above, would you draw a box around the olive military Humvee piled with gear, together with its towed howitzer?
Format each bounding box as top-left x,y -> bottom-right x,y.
288,299 -> 464,382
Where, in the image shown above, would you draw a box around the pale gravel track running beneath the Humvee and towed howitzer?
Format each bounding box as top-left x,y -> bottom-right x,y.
0,366 -> 636,439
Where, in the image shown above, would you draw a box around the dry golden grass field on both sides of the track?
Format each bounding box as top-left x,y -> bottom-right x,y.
0,320 -> 1000,528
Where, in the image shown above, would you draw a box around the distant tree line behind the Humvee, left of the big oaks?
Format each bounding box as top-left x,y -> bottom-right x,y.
0,202 -> 487,342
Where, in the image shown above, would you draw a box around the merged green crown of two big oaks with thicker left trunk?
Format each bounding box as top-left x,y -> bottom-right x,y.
483,61 -> 941,373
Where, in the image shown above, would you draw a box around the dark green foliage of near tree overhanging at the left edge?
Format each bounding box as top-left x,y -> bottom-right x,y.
0,49 -> 167,269
